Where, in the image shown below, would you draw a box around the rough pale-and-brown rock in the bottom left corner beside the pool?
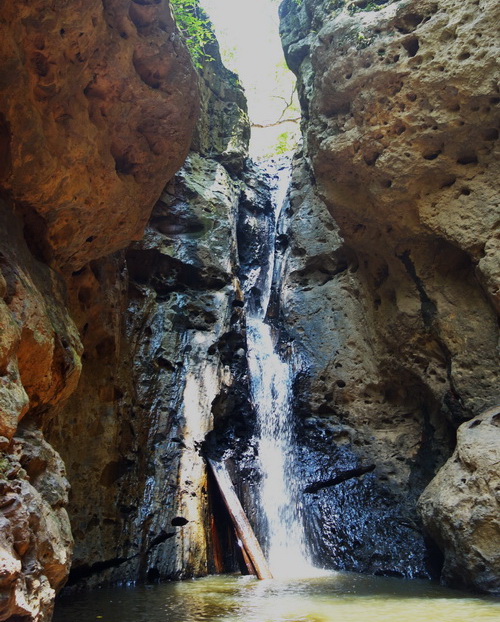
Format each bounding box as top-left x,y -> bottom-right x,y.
0,429 -> 73,622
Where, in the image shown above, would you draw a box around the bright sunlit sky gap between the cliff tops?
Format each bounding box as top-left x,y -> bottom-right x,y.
200,0 -> 300,159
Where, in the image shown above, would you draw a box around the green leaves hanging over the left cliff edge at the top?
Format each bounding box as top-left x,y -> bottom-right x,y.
170,0 -> 215,69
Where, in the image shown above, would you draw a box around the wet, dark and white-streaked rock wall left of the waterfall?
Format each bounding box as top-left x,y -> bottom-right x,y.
47,31 -> 254,587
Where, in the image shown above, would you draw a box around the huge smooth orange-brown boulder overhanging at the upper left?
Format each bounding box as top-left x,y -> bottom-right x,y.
0,0 -> 198,269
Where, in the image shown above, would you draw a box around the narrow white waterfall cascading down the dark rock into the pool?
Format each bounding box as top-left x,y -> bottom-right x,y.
247,160 -> 312,578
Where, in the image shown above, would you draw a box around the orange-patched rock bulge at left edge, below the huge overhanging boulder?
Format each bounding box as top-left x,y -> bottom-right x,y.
0,200 -> 82,438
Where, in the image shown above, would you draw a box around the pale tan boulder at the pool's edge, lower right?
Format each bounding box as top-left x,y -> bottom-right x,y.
419,407 -> 500,594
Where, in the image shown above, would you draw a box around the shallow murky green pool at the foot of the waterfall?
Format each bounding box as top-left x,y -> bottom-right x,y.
54,573 -> 500,622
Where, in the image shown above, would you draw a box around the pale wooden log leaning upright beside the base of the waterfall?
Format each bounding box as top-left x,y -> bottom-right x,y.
207,458 -> 273,579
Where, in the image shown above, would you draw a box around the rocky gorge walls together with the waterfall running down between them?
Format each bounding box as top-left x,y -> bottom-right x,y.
0,0 -> 500,622
